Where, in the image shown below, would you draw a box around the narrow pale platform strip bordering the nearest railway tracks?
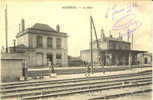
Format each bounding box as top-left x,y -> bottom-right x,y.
1,67 -> 152,86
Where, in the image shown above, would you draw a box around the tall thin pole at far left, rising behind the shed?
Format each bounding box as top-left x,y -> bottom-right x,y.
5,4 -> 8,53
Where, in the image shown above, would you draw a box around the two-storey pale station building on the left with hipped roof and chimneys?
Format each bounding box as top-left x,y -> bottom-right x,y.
10,20 -> 68,66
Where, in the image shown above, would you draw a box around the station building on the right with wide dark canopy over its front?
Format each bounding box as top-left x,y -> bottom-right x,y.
80,30 -> 145,65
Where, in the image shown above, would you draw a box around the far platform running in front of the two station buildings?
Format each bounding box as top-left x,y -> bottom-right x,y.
28,65 -> 152,77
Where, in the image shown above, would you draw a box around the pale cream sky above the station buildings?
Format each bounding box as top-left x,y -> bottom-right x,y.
0,0 -> 152,56
